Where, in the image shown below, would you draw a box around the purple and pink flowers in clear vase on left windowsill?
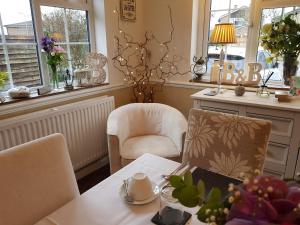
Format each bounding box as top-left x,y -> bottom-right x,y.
41,33 -> 65,89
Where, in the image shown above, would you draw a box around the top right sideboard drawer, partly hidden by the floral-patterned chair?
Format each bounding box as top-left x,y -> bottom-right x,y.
246,112 -> 294,144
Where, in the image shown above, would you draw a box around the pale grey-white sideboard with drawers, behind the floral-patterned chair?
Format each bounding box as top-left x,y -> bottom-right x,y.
191,89 -> 300,178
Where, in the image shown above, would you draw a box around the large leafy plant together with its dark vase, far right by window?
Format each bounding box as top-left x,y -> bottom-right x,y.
260,14 -> 300,85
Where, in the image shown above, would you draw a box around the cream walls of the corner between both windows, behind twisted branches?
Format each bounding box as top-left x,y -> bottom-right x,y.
94,0 -> 193,84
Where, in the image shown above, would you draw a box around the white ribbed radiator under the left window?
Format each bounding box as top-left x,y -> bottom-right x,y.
0,96 -> 114,171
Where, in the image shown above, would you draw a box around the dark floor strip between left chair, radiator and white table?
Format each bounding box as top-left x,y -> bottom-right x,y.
77,165 -> 110,194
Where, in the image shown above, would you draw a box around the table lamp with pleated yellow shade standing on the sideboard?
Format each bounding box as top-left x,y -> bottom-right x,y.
210,23 -> 236,95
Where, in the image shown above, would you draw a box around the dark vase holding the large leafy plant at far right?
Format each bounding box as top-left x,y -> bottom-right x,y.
283,54 -> 298,85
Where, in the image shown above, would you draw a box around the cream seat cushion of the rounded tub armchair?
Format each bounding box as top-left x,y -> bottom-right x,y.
120,135 -> 180,159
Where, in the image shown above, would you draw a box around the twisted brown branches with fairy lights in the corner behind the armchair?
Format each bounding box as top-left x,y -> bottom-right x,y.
112,6 -> 190,102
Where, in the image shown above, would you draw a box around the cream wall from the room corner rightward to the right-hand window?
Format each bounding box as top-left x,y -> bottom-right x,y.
144,0 -> 193,81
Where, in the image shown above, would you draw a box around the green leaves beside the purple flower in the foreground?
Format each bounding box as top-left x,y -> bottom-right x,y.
170,171 -> 227,225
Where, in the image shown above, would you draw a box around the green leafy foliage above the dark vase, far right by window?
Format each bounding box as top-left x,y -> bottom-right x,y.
260,14 -> 300,61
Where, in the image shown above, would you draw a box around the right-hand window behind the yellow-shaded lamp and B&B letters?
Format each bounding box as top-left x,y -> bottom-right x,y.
197,0 -> 300,86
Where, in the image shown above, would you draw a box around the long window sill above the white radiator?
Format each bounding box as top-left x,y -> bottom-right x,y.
0,83 -> 127,117
